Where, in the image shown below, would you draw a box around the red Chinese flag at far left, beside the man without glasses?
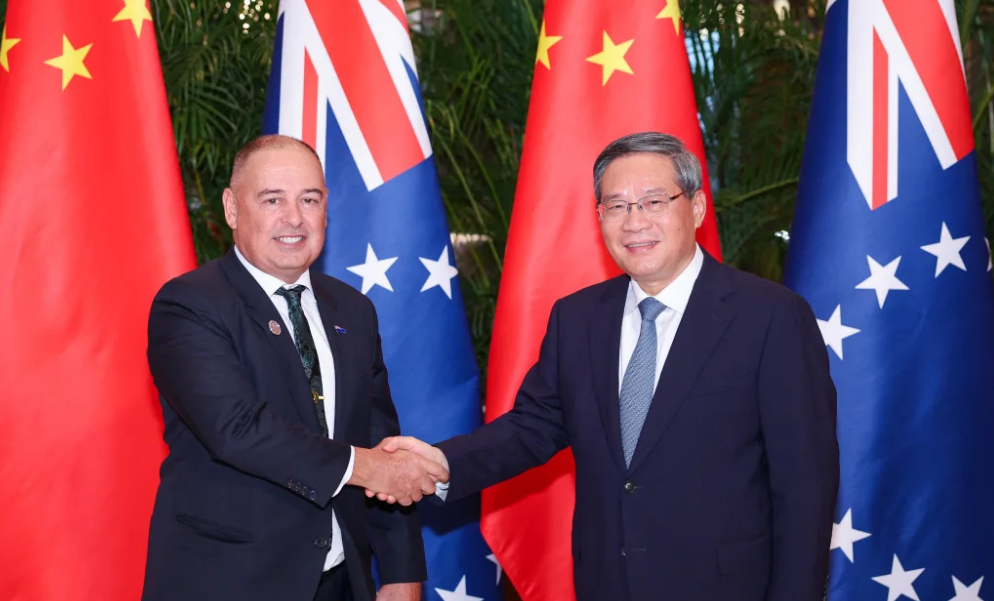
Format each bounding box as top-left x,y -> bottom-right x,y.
0,0 -> 196,601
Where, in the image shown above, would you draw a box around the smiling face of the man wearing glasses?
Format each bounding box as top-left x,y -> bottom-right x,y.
600,152 -> 706,295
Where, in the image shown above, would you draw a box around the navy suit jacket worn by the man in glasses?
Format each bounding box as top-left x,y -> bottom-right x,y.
438,255 -> 839,601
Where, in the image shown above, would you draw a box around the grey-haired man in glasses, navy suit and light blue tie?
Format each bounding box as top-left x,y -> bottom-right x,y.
367,133 -> 839,601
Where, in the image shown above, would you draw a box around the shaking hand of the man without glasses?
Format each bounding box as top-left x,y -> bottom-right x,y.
347,447 -> 449,506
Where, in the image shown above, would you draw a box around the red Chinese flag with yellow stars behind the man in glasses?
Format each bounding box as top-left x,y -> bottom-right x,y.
481,0 -> 721,601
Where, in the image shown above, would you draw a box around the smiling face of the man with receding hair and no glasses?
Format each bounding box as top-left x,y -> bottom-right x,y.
224,143 -> 328,284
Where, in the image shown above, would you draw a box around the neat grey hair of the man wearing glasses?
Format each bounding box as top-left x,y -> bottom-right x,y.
594,131 -> 704,202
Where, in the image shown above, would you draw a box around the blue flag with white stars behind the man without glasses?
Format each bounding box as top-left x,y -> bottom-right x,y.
263,0 -> 502,601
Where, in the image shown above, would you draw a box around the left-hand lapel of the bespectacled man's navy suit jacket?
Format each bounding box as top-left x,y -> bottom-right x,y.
590,276 -> 631,473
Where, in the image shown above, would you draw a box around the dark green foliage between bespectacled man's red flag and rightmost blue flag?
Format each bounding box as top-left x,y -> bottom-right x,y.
684,0 -> 823,280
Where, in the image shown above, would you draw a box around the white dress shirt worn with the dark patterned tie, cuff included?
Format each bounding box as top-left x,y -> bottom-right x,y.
235,246 -> 355,570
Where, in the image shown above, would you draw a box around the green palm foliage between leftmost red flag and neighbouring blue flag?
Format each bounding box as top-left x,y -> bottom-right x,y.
152,0 -> 277,262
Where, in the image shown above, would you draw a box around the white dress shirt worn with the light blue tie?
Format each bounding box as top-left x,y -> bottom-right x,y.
618,246 -> 704,396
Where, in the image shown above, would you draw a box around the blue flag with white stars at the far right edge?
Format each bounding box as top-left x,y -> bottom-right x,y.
785,0 -> 994,601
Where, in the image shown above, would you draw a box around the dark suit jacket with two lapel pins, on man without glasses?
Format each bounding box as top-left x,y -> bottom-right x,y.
142,252 -> 427,601
